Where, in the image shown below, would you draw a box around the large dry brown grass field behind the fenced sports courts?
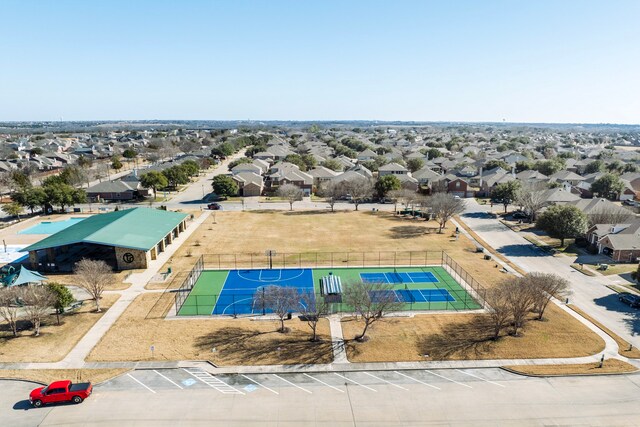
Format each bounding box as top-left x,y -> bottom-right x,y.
168,211 -> 508,289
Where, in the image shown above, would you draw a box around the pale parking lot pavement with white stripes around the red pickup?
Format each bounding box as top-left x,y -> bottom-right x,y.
5,369 -> 640,426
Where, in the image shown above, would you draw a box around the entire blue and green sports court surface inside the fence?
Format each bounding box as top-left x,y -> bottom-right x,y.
178,266 -> 482,316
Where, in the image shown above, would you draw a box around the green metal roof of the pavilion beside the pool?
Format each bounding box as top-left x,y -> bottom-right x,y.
21,208 -> 188,252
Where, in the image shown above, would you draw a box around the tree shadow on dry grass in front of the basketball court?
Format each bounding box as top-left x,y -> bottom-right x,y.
195,327 -> 333,365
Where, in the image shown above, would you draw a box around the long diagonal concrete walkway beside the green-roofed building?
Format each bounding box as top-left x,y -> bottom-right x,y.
37,211 -> 210,369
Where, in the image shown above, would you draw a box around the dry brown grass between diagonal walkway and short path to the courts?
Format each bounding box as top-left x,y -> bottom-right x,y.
87,293 -> 333,366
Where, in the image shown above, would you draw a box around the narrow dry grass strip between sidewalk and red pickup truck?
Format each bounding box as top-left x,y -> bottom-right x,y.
0,368 -> 129,384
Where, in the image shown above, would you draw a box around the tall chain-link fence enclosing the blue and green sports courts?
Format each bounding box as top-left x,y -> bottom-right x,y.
175,251 -> 487,316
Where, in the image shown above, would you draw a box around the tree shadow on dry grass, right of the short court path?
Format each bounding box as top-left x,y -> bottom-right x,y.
417,316 -> 496,360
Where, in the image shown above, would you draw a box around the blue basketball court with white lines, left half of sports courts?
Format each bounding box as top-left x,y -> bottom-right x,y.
211,269 -> 313,315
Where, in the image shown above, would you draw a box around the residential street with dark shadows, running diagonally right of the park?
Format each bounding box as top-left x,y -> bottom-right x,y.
460,199 -> 640,346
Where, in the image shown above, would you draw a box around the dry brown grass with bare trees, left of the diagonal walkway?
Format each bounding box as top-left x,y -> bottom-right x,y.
0,294 -> 120,363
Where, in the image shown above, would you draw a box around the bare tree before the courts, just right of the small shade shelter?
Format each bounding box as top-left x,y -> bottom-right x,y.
343,282 -> 402,341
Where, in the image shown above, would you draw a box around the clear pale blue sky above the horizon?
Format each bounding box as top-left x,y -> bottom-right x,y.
0,0 -> 640,124
